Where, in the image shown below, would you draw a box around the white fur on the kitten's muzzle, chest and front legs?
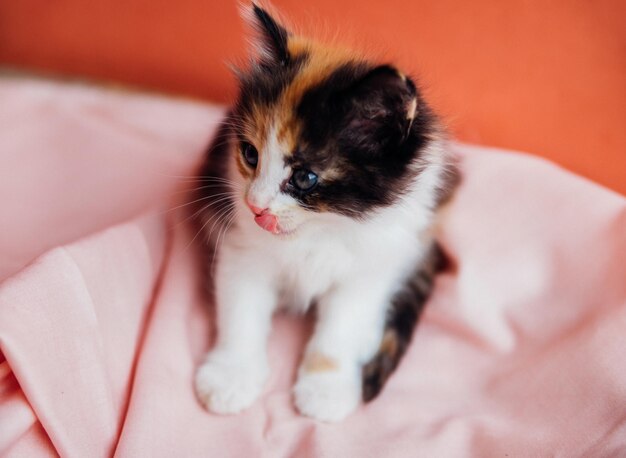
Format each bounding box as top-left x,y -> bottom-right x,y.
196,125 -> 445,421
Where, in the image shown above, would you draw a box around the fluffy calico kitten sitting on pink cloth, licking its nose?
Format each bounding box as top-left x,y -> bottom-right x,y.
195,4 -> 456,421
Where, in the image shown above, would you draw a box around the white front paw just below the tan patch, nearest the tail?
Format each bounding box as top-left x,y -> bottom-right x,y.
294,372 -> 361,422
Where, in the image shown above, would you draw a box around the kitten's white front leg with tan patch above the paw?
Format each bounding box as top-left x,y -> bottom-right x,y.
294,278 -> 390,421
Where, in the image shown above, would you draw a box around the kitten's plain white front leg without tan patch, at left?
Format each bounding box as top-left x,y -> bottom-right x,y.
195,250 -> 276,414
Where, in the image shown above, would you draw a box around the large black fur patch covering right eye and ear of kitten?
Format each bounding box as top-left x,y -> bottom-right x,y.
286,62 -> 435,218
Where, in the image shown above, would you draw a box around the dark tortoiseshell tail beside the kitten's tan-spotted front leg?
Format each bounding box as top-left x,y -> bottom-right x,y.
362,243 -> 445,402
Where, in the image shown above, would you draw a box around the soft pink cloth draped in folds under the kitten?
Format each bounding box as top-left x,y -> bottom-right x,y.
0,78 -> 626,457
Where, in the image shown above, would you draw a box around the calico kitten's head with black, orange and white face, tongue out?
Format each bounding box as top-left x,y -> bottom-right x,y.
230,4 -> 434,234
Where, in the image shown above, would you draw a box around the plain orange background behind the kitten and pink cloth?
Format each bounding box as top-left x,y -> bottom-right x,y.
0,0 -> 626,194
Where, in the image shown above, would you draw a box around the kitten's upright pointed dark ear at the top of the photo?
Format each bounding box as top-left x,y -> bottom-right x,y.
241,3 -> 291,67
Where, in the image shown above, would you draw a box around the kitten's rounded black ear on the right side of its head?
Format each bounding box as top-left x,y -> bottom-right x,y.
342,65 -> 419,153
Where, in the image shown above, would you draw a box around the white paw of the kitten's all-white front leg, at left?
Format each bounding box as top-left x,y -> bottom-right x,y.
196,355 -> 269,414
